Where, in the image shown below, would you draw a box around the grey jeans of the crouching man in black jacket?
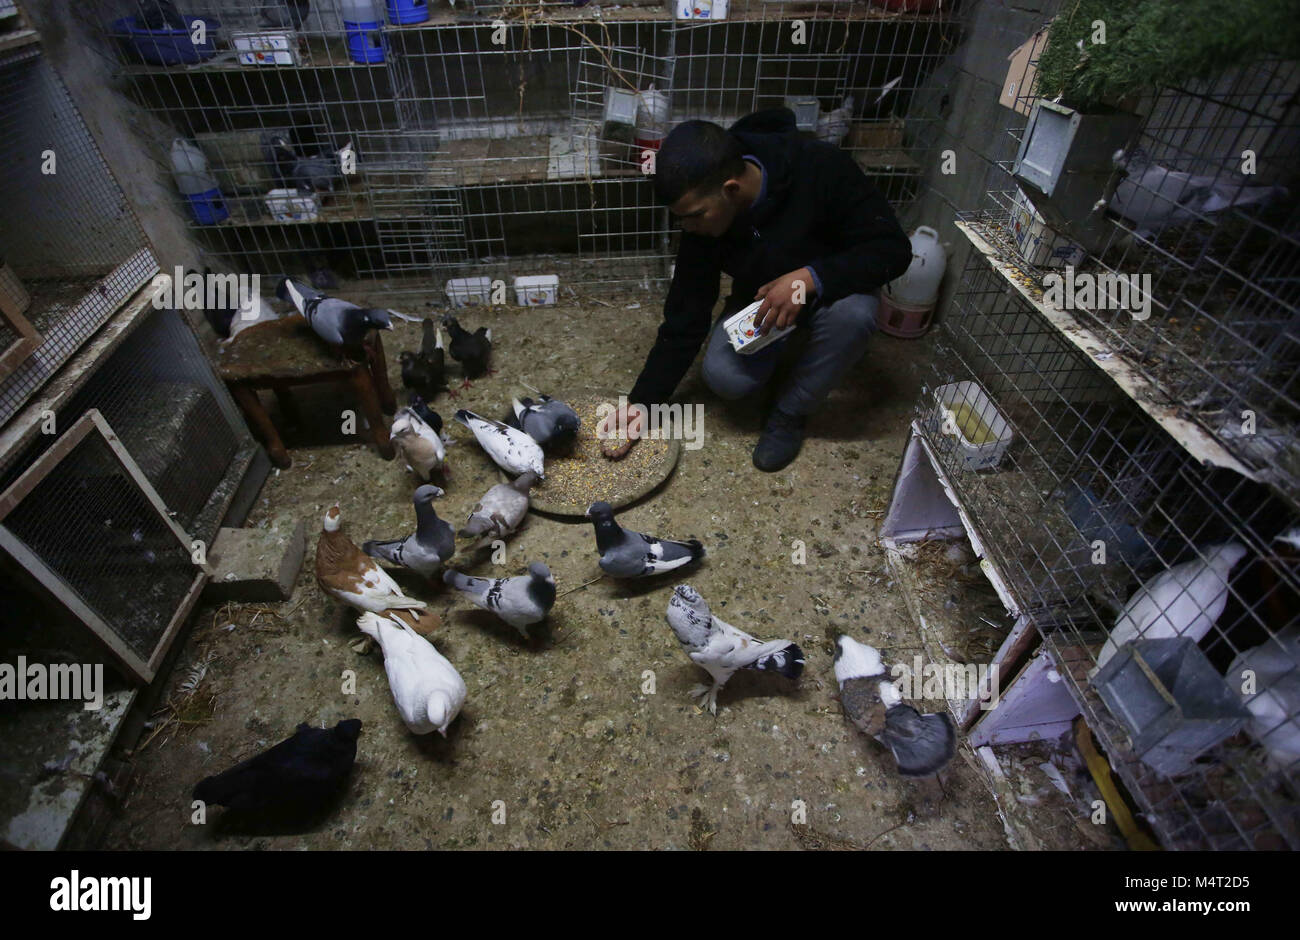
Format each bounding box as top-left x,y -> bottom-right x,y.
703,294 -> 879,415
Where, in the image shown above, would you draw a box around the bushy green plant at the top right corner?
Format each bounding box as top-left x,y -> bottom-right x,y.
1037,0 -> 1300,112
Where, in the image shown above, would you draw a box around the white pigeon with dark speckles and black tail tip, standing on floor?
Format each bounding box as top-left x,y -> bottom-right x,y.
668,584 -> 803,715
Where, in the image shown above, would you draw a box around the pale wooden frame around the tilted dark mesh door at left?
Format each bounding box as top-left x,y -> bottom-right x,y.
0,408 -> 212,683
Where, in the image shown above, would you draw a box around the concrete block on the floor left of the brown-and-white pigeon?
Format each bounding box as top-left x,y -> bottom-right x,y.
203,521 -> 307,603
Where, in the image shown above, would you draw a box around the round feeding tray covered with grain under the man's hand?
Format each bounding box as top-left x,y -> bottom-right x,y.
514,397 -> 681,517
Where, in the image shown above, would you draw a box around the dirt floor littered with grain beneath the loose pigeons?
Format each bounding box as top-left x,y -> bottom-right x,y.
104,288 -> 1105,849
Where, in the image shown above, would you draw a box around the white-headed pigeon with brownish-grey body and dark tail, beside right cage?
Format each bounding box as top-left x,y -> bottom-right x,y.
835,634 -> 957,776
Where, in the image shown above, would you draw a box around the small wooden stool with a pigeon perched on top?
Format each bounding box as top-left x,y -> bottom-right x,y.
216,316 -> 397,468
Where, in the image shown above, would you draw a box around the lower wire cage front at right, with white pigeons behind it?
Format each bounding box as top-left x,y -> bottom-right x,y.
920,245 -> 1300,848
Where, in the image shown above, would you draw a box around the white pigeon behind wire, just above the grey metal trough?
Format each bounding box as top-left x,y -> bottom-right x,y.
1093,542 -> 1245,675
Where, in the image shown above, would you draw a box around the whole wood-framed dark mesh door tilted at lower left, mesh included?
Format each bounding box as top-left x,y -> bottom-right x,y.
0,411 -> 203,681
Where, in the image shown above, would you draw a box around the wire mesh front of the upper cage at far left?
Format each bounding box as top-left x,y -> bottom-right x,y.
0,49 -> 157,421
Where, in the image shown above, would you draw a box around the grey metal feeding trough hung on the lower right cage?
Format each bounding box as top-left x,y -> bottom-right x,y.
1092,637 -> 1251,776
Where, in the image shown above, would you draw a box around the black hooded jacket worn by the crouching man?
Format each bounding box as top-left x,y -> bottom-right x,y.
629,108 -> 911,404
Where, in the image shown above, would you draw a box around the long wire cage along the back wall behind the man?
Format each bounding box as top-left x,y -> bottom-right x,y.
85,0 -> 957,291
